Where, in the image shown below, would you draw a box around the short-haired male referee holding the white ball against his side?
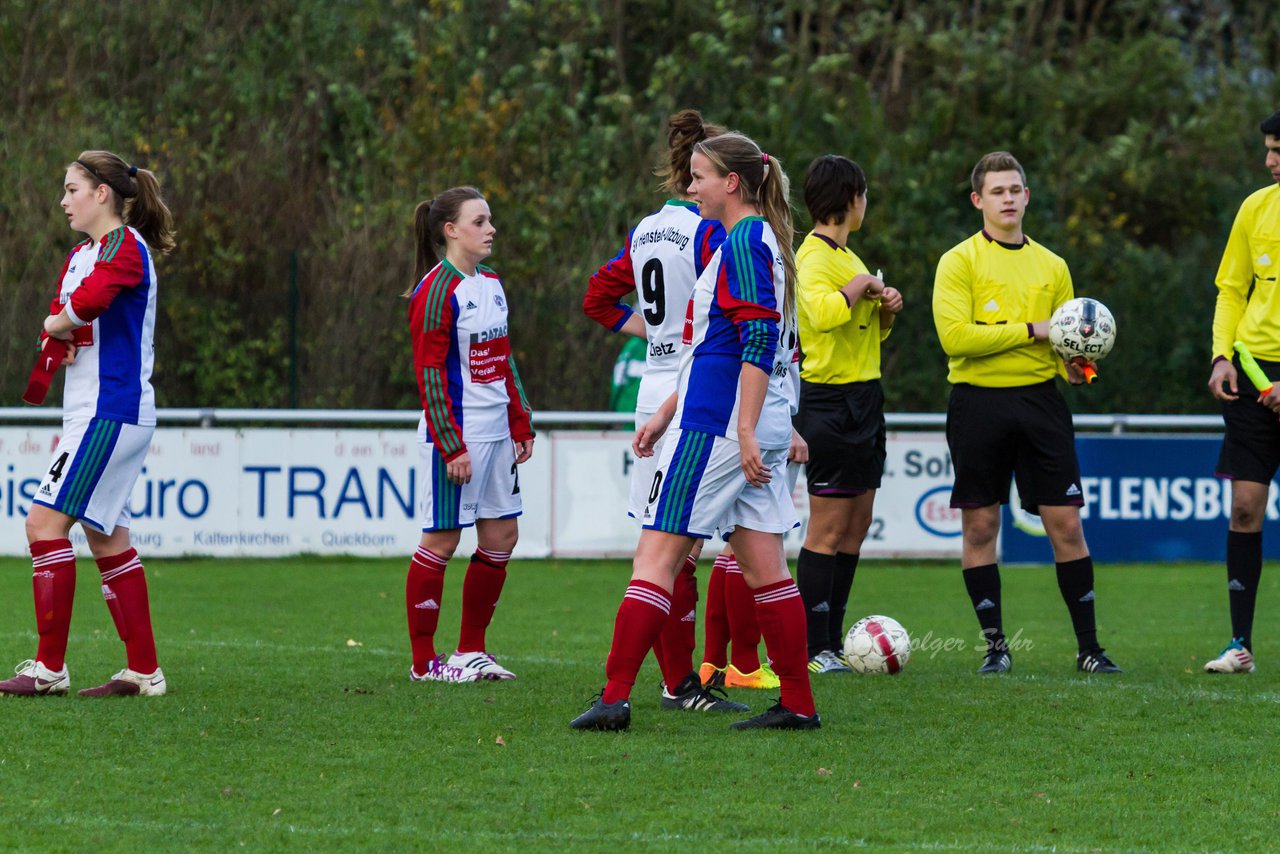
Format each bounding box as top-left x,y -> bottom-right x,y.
933,151 -> 1120,673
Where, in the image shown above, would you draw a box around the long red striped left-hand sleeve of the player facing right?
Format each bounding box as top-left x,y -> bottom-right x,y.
410,265 -> 467,462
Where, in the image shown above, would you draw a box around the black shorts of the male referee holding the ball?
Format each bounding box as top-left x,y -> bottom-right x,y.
947,380 -> 1084,513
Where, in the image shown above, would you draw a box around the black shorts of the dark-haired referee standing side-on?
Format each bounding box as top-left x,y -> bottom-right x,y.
795,380 -> 884,498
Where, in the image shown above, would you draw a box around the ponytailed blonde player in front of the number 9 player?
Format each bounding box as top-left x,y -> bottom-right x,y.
571,133 -> 820,730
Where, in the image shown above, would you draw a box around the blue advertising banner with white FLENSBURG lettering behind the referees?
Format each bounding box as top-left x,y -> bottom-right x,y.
1001,435 -> 1280,563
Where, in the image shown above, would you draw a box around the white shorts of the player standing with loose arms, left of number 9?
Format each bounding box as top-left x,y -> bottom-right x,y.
417,438 -> 524,531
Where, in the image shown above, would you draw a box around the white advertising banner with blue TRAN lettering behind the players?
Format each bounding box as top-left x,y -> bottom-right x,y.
0,426 -> 960,557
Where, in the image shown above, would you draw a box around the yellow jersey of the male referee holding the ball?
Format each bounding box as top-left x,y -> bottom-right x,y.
933,230 -> 1073,388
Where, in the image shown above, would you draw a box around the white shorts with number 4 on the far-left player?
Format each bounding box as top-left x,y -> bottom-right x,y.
32,419 -> 156,535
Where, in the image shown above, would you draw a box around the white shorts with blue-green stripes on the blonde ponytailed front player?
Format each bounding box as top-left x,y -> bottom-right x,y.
643,429 -> 800,539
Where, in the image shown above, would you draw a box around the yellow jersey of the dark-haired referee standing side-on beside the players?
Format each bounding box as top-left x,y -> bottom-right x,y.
796,233 -> 892,384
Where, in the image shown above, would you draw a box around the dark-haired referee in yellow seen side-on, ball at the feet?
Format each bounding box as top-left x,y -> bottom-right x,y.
796,154 -> 902,673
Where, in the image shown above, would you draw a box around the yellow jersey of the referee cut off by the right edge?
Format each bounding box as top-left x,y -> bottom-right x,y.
1213,184 -> 1280,362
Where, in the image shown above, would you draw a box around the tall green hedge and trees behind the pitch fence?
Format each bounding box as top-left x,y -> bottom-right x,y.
0,0 -> 1280,412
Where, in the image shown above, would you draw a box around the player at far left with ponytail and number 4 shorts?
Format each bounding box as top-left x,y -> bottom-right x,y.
0,151 -> 174,697
